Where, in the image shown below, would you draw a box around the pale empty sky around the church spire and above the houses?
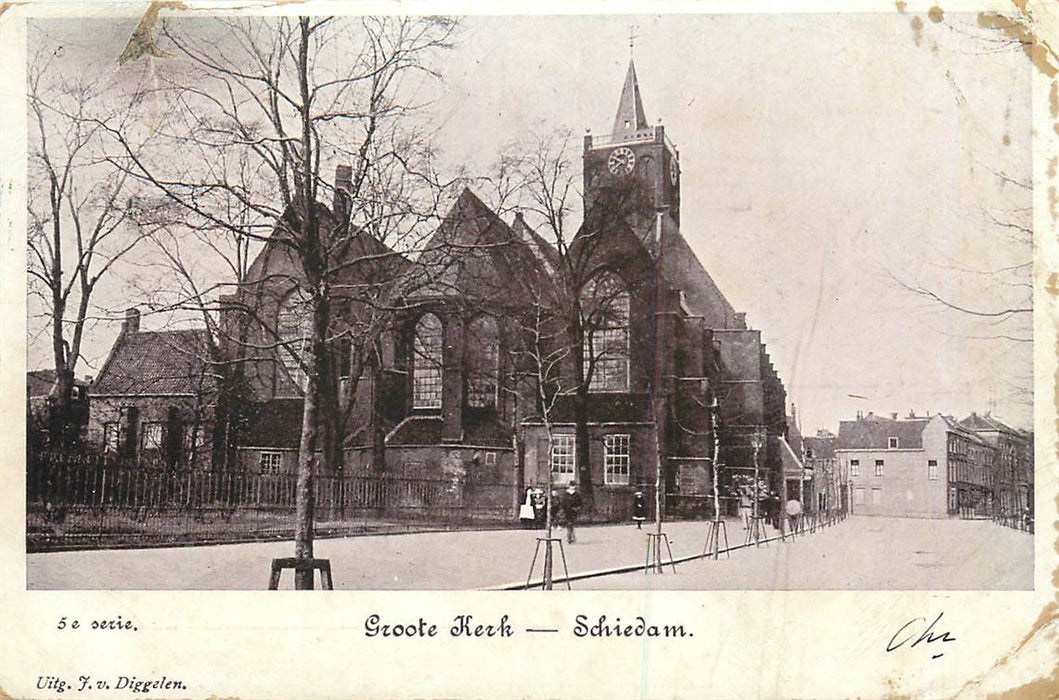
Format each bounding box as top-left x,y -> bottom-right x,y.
22,12 -> 1031,433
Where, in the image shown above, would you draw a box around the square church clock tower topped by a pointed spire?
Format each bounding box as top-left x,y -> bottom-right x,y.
584,58 -> 680,240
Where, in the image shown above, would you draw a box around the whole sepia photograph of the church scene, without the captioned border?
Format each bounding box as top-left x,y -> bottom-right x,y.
25,9 -> 1035,591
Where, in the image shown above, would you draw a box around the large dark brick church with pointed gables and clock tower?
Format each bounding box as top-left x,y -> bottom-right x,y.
86,55 -> 787,520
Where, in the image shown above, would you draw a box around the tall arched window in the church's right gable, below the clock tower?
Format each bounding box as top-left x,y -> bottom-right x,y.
581,272 -> 629,392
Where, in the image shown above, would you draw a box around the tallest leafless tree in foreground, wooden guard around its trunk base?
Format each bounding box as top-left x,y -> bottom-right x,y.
104,17 -> 454,589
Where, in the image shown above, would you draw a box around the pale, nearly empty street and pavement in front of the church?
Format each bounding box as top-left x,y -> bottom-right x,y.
26,516 -> 1034,590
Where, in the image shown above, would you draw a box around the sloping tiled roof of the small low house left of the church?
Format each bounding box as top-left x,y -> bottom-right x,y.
91,328 -> 214,396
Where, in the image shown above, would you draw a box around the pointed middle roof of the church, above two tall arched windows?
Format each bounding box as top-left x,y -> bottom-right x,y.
411,187 -> 552,302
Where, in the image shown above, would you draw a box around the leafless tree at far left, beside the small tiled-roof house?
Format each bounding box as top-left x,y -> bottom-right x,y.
26,40 -> 153,444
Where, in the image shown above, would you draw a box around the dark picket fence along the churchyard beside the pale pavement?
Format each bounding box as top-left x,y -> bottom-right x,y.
26,453 -> 518,549
